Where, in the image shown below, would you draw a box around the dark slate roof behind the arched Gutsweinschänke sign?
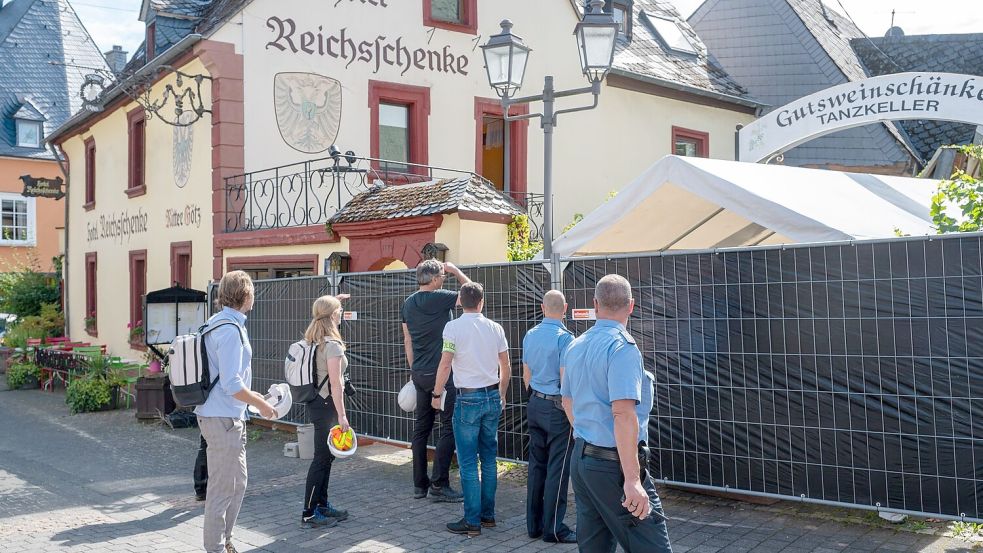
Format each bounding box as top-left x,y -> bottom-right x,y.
850,33 -> 983,159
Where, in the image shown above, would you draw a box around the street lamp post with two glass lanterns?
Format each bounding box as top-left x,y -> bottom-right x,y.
481,0 -> 618,260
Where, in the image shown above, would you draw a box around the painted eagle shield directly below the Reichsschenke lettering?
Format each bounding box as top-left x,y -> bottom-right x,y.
273,73 -> 341,154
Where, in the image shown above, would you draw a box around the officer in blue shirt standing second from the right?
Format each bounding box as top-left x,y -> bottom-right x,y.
522,290 -> 577,543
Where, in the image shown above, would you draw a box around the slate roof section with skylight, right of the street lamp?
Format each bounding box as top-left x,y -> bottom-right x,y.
577,0 -> 757,104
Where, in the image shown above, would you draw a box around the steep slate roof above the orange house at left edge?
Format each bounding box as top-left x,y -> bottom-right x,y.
0,0 -> 109,159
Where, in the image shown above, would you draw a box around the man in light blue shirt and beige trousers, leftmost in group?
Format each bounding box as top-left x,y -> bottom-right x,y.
195,271 -> 277,553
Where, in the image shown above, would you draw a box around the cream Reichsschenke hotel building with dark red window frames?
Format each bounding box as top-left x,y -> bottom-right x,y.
53,0 -> 761,350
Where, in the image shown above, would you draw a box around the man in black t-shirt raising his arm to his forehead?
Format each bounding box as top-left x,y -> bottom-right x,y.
401,259 -> 471,502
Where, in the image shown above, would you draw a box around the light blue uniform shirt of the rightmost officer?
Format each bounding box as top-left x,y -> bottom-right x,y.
560,319 -> 653,447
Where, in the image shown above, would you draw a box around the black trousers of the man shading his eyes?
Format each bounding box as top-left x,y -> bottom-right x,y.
411,369 -> 457,489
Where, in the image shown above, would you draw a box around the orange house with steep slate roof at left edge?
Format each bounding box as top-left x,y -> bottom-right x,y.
0,0 -> 106,272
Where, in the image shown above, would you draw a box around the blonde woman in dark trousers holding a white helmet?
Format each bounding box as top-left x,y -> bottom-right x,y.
301,294 -> 349,528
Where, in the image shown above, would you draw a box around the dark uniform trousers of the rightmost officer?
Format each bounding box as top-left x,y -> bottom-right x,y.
570,439 -> 672,553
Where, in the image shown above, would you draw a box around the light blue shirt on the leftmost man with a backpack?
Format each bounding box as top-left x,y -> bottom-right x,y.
195,307 -> 253,419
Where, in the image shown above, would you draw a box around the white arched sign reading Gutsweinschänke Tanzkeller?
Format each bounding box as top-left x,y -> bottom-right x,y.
738,73 -> 983,162
